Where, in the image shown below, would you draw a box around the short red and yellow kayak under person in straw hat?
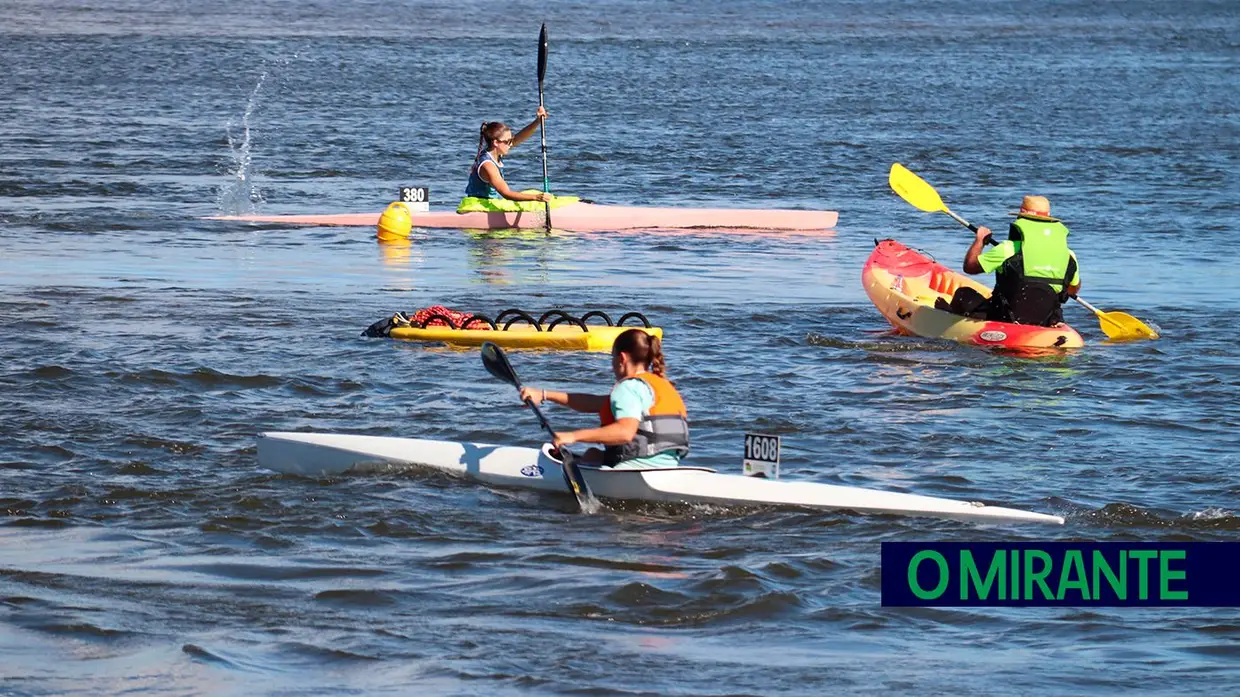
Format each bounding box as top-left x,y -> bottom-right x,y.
861,239 -> 1085,350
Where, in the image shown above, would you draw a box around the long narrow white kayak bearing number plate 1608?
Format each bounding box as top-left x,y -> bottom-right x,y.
258,432 -> 1064,525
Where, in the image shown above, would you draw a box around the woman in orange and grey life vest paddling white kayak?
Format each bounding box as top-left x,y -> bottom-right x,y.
521,329 -> 689,469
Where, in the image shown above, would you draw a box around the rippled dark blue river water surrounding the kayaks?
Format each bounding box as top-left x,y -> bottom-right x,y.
0,0 -> 1240,695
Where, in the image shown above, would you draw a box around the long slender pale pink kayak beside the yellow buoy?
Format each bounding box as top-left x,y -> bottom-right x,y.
206,202 -> 839,232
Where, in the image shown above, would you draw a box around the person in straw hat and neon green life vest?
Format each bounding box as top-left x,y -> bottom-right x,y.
935,196 -> 1081,326
